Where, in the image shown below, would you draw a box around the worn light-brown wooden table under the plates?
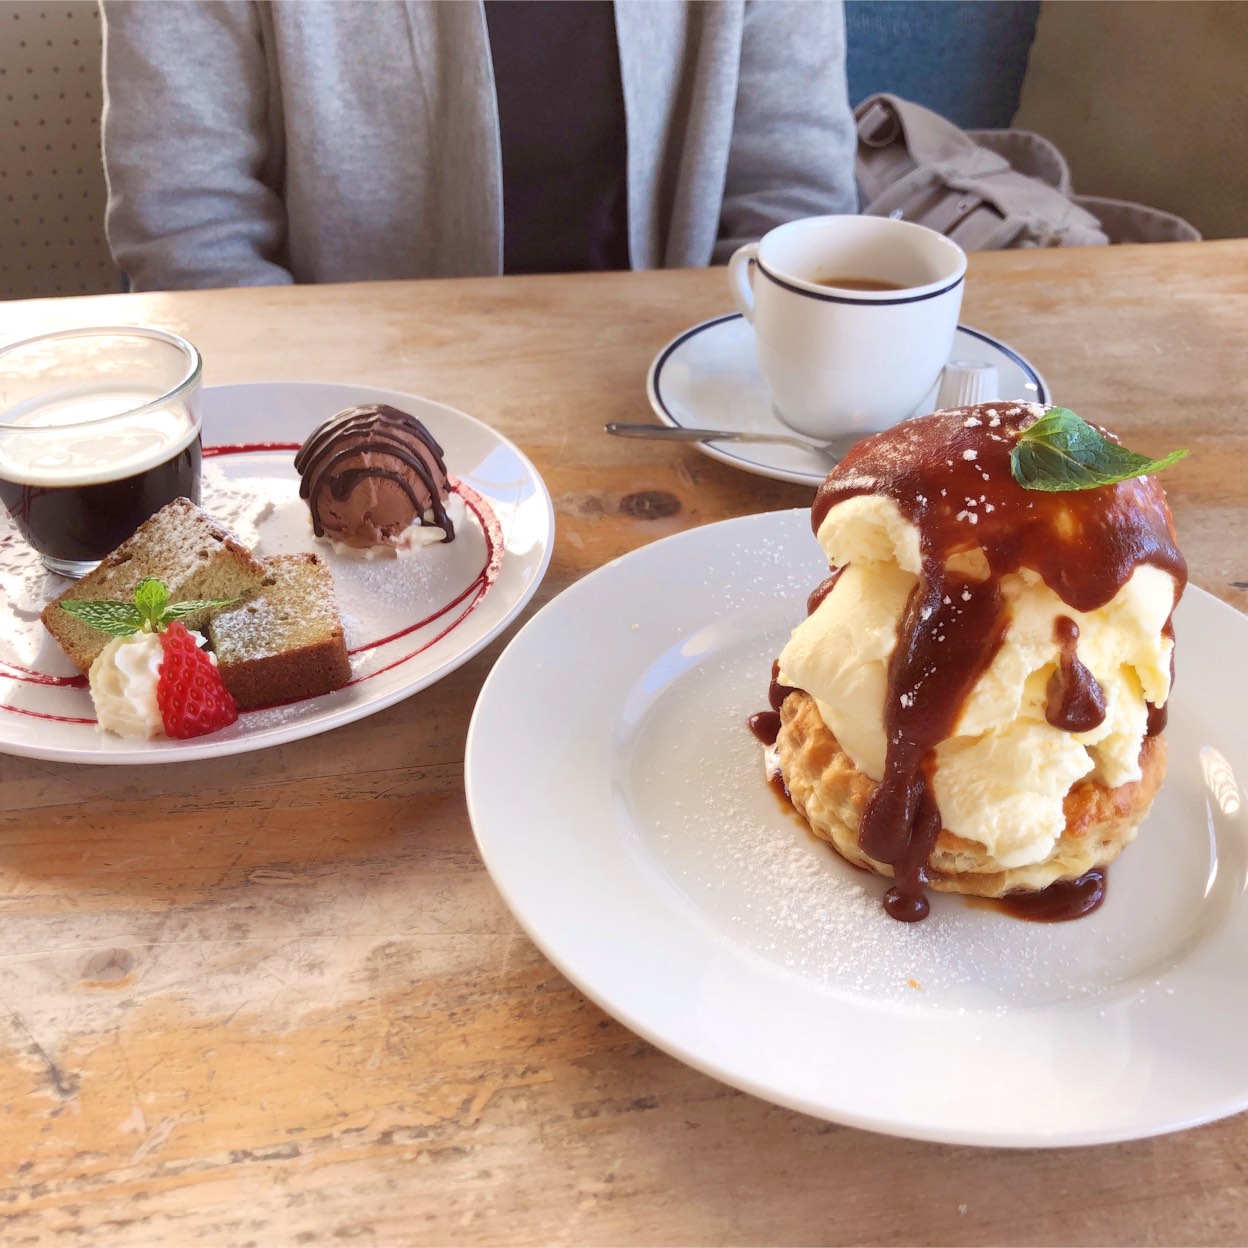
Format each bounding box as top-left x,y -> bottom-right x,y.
0,241 -> 1248,1248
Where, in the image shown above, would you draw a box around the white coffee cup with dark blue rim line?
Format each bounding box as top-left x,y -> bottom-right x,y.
728,216 -> 966,441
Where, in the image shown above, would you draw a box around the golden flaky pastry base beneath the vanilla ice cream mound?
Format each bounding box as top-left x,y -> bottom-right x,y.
776,690 -> 1166,897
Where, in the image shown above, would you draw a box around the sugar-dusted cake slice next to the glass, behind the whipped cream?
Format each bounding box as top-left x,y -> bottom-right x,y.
40,498 -> 265,671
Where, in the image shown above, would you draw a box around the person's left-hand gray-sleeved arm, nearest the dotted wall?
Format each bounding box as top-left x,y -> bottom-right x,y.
101,0 -> 292,291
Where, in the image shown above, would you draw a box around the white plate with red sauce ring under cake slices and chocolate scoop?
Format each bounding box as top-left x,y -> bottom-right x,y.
0,382 -> 554,763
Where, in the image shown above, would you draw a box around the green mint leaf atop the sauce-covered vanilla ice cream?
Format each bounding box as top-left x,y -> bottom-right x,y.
1010,407 -> 1187,493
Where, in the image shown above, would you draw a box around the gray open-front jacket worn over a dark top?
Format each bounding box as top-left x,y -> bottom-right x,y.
102,0 -> 857,290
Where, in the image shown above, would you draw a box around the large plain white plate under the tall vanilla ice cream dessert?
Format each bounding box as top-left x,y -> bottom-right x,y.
466,512 -> 1248,1147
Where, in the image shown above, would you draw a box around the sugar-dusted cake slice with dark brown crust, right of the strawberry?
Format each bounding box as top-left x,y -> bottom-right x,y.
207,554 -> 351,710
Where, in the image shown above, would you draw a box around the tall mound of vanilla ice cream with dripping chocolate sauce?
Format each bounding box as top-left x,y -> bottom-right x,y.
778,403 -> 1186,923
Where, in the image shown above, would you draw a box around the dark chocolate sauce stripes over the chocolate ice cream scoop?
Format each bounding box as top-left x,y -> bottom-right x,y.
295,403 -> 456,542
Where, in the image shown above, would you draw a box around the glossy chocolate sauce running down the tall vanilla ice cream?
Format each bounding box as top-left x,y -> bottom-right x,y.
798,403 -> 1187,921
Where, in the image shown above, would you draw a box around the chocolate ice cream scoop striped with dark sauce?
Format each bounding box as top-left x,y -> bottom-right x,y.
295,403 -> 456,549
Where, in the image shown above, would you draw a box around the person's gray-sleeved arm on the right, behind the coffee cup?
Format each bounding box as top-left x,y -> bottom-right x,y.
715,0 -> 857,261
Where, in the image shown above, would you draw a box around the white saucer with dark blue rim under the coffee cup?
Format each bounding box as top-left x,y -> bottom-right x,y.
645,312 -> 1050,485
